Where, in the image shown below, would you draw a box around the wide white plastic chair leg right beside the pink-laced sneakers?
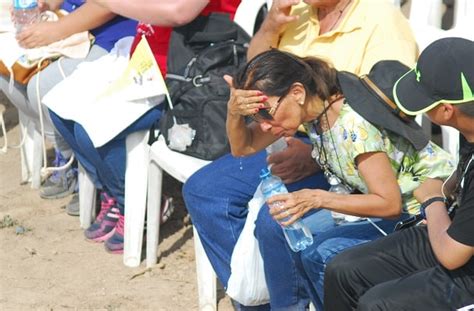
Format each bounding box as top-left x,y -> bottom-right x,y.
123,131 -> 150,267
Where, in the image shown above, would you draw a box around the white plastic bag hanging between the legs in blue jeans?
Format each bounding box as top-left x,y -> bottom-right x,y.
226,186 -> 270,306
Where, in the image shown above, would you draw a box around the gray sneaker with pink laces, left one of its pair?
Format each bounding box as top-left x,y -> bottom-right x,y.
84,192 -> 120,242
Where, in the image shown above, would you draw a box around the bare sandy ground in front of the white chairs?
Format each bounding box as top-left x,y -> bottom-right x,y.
0,92 -> 232,310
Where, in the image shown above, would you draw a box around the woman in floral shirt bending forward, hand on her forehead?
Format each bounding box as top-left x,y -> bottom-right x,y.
225,50 -> 453,306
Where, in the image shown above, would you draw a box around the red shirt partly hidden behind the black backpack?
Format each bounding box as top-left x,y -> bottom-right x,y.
131,0 -> 240,77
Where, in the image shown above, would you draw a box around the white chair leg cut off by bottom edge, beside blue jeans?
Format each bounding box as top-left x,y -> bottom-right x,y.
193,227 -> 217,311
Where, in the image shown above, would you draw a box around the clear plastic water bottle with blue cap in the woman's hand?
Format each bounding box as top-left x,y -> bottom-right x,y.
260,169 -> 313,252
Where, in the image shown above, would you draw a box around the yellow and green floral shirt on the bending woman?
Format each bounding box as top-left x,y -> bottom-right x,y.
305,104 -> 455,214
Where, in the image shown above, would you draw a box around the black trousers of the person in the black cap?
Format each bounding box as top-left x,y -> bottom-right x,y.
324,227 -> 474,311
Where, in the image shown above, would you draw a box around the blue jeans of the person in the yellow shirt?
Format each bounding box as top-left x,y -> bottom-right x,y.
183,147 -> 328,310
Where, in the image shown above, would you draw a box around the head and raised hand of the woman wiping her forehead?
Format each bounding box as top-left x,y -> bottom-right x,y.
225,50 -> 342,156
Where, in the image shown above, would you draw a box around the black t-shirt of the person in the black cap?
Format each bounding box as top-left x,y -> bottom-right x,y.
448,138 -> 474,270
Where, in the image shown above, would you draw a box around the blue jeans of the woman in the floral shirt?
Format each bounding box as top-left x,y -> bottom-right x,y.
292,210 -> 404,310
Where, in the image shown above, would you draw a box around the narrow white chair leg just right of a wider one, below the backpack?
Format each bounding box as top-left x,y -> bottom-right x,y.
146,155 -> 163,268
